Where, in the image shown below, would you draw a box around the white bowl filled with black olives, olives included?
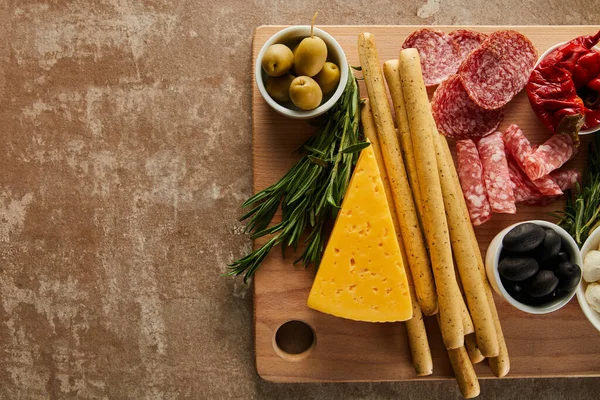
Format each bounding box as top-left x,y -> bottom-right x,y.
485,220 -> 582,314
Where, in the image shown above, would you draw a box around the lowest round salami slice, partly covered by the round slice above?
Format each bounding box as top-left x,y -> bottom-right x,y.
431,75 -> 504,139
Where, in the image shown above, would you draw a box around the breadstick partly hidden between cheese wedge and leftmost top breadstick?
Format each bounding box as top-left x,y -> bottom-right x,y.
361,100 -> 433,376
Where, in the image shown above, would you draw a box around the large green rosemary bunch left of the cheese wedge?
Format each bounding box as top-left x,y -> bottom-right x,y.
227,68 -> 369,282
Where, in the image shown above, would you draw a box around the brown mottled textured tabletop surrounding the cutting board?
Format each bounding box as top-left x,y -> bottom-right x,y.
0,0 -> 600,399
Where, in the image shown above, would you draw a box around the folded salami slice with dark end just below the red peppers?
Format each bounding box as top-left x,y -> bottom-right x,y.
523,135 -> 576,180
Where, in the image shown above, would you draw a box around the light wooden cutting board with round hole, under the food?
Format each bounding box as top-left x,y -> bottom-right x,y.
252,26 -> 600,382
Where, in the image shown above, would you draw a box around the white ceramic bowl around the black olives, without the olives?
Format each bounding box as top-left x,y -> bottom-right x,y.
485,220 -> 582,314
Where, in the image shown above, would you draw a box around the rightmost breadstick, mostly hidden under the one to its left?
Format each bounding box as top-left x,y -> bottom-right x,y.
440,136 -> 510,378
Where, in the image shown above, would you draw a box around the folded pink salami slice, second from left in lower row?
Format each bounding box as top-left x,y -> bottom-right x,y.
477,132 -> 517,214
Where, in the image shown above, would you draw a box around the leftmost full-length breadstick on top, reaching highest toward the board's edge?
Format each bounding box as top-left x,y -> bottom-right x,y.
358,33 -> 438,315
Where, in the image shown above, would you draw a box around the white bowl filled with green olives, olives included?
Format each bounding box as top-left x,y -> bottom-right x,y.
254,25 -> 349,119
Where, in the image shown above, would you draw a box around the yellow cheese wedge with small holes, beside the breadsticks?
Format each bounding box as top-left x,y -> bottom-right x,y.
308,146 -> 412,322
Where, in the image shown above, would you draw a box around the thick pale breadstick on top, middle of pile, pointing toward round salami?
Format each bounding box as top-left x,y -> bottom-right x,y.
400,49 -> 464,349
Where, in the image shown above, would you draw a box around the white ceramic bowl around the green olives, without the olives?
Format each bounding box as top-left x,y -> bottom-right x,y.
254,25 -> 348,119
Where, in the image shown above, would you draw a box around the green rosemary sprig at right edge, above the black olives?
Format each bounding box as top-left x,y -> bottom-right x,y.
552,134 -> 600,247
